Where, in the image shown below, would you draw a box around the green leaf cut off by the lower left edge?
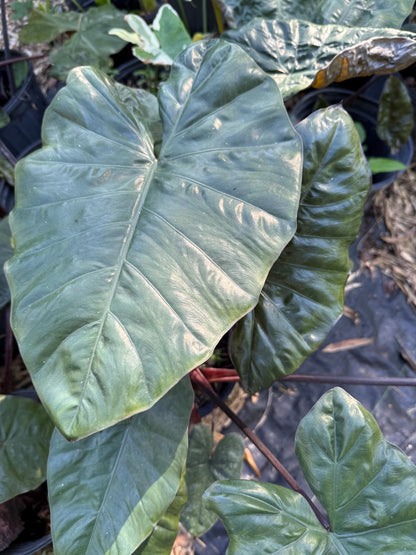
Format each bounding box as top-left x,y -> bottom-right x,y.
0,395 -> 53,503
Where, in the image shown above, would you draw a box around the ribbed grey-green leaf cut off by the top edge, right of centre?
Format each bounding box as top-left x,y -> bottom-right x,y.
219,0 -> 414,29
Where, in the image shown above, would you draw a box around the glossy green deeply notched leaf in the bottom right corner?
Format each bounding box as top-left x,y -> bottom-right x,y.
206,388 -> 416,555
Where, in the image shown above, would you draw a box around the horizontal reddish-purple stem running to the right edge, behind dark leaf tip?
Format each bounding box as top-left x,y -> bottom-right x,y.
201,367 -> 416,387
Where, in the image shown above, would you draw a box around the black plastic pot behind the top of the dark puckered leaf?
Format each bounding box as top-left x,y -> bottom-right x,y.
292,87 -> 413,191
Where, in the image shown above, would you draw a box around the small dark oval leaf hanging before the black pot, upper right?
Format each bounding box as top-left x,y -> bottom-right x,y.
377,76 -> 414,154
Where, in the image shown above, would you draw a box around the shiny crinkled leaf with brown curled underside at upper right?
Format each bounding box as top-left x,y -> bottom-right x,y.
222,19 -> 416,98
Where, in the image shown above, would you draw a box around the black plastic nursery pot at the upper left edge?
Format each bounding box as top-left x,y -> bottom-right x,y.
0,50 -> 47,159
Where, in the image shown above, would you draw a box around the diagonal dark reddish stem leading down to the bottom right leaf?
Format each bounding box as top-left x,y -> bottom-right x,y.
191,368 -> 330,531
